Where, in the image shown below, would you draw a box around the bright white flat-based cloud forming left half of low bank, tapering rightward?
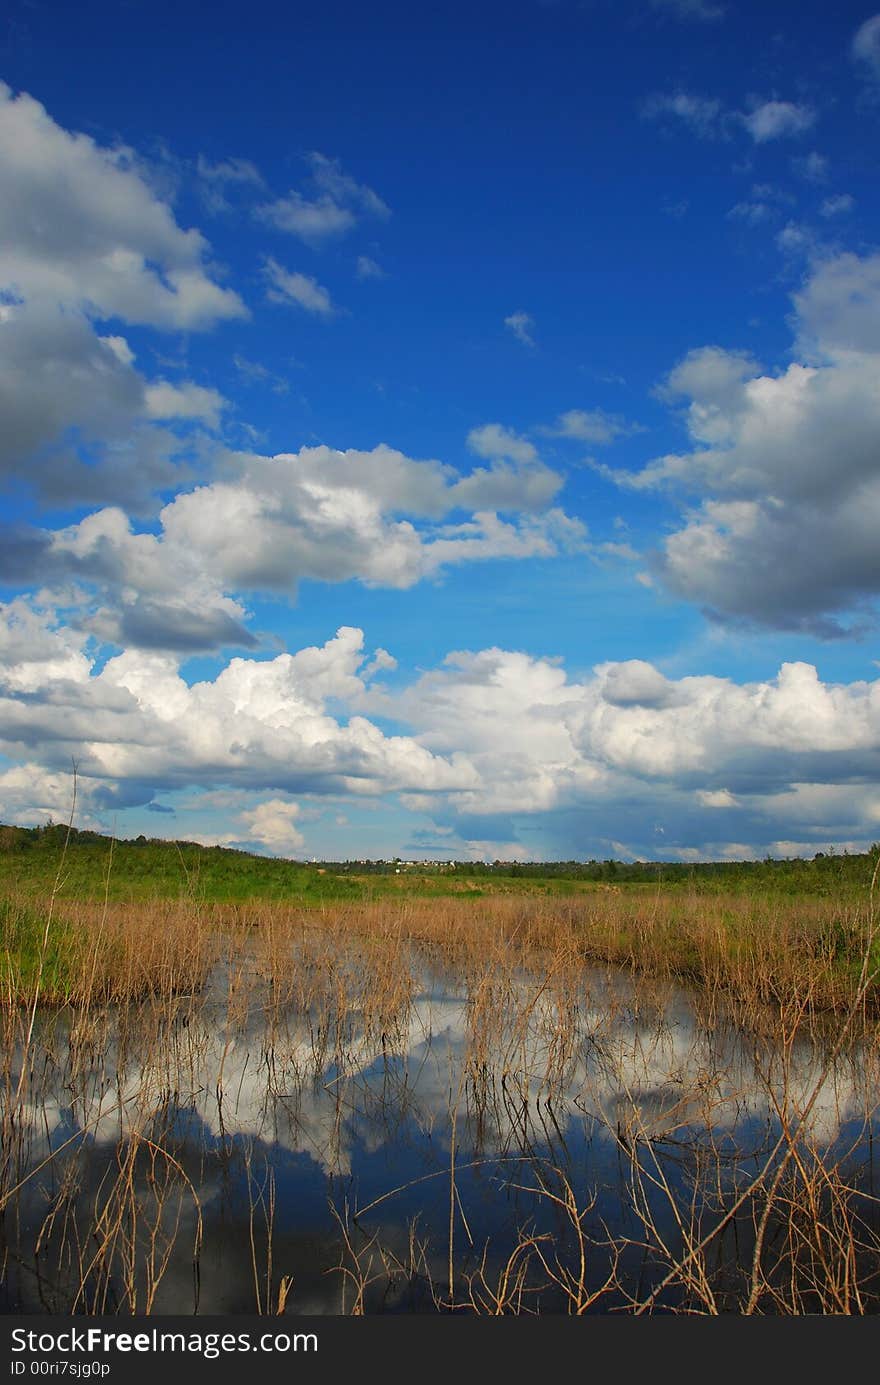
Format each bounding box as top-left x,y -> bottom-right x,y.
0,614 -> 474,803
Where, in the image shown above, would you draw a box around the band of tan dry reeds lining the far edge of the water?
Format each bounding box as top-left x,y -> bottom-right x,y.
0,891 -> 880,1014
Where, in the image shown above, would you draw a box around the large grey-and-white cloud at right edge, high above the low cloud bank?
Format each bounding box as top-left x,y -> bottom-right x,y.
606,253 -> 880,637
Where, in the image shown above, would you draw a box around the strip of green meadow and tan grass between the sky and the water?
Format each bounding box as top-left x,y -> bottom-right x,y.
0,824 -> 880,1008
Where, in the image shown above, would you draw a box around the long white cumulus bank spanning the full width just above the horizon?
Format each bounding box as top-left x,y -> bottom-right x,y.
0,602 -> 880,859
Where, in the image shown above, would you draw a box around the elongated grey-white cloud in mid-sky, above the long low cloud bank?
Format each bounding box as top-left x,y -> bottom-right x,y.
161,446 -> 575,590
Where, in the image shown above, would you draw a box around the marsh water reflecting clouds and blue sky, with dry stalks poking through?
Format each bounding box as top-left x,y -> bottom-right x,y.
3,956 -> 877,1313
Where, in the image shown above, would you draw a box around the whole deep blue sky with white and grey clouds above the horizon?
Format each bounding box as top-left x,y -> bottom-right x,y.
0,0 -> 880,861
